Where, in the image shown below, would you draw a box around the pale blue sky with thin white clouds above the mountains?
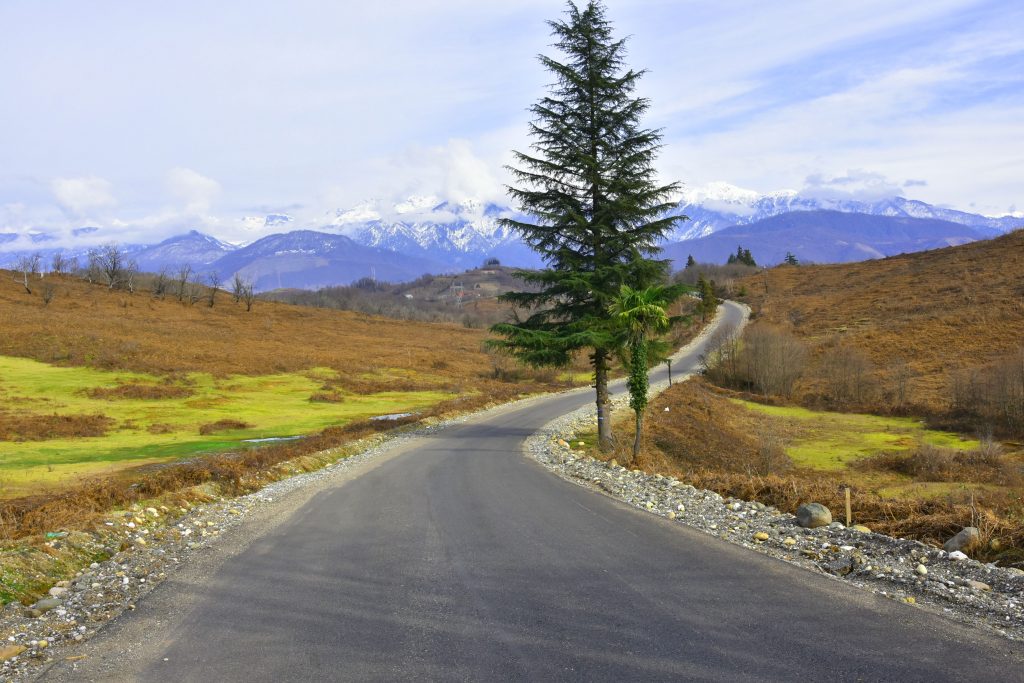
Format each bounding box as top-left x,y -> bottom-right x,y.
0,0 -> 1024,243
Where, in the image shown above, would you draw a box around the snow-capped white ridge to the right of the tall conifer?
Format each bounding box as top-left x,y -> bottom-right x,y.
668,182 -> 1024,242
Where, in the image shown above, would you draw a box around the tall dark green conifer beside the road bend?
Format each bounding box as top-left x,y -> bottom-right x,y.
493,1 -> 685,450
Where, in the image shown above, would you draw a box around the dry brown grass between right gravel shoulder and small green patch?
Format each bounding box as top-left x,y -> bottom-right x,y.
606,378 -> 1024,564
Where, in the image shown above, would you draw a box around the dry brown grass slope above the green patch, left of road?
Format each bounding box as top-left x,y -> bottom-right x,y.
0,271 -> 516,381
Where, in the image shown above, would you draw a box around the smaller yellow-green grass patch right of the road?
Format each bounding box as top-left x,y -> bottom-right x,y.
732,399 -> 978,470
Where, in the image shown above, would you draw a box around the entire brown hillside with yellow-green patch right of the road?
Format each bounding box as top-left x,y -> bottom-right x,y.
584,230 -> 1024,566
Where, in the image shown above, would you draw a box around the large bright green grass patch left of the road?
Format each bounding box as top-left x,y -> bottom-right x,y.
0,356 -> 450,497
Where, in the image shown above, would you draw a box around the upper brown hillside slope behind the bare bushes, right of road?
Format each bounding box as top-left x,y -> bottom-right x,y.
743,230 -> 1024,415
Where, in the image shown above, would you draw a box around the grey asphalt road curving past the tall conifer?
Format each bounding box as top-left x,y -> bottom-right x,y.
44,309 -> 1024,682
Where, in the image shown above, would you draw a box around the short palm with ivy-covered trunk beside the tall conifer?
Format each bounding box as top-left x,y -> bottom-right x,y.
611,285 -> 685,463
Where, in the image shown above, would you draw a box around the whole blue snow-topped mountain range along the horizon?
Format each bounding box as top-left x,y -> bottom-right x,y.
0,183 -> 1024,290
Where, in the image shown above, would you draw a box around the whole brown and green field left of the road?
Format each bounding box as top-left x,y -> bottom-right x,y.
0,273 -> 587,500
